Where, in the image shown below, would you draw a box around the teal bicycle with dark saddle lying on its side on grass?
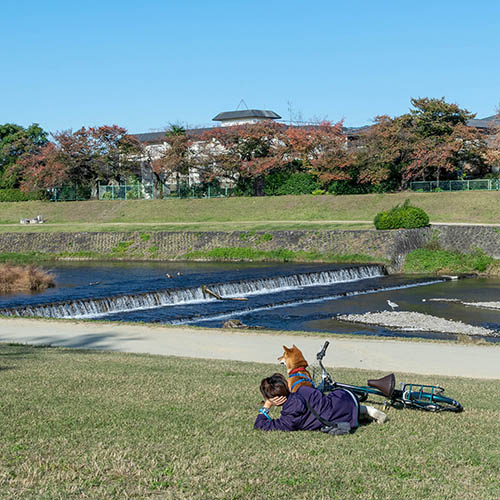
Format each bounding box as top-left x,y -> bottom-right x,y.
313,341 -> 463,413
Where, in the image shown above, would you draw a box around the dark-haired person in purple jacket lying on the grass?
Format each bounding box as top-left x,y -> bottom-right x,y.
254,373 -> 387,434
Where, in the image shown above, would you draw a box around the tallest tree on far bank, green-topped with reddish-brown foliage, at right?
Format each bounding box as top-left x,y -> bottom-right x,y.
356,98 -> 485,189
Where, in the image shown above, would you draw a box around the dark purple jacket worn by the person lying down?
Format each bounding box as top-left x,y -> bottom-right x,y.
254,386 -> 359,431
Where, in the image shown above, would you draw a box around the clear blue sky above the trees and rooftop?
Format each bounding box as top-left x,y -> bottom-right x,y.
0,0 -> 500,133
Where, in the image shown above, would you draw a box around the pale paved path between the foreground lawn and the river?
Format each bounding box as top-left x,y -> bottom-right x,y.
0,318 -> 500,379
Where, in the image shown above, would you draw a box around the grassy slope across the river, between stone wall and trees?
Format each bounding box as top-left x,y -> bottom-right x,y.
0,191 -> 500,231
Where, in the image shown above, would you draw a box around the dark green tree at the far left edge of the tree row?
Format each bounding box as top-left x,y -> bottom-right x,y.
0,123 -> 48,187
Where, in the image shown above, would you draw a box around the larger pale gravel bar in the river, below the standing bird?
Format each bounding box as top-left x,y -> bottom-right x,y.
335,311 -> 500,337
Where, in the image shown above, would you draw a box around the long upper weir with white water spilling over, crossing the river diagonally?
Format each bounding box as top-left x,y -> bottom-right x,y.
0,264 -> 386,318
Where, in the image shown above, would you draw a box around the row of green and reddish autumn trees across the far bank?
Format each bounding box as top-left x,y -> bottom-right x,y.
0,98 -> 500,196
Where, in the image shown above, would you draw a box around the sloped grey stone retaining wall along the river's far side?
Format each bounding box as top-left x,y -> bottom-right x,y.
0,226 -> 500,267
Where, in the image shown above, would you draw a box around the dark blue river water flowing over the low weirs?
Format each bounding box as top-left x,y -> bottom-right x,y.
0,263 -> 500,338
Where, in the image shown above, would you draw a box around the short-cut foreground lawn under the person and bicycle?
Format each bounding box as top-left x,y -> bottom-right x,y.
0,344 -> 500,499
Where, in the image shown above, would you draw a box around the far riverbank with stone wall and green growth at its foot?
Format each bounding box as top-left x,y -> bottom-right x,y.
0,226 -> 500,276
